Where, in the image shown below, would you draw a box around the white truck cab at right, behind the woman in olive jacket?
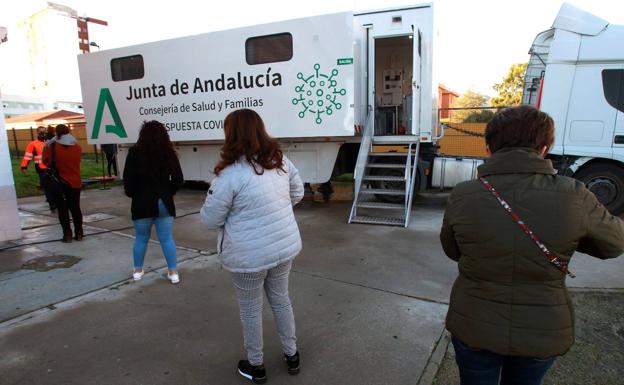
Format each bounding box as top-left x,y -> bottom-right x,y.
523,3 -> 624,214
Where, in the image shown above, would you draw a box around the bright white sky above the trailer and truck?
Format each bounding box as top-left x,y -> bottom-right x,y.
0,0 -> 624,96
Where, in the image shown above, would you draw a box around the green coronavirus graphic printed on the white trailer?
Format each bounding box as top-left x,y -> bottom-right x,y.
292,63 -> 347,124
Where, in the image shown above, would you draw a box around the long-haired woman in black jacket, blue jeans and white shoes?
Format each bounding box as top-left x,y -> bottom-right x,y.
123,120 -> 184,283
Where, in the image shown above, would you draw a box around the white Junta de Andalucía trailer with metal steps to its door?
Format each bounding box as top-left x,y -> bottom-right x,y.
78,4 -> 438,226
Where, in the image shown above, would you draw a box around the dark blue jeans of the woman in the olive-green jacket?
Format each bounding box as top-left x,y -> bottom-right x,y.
453,337 -> 555,385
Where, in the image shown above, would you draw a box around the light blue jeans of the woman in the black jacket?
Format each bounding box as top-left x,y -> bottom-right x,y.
132,199 -> 177,270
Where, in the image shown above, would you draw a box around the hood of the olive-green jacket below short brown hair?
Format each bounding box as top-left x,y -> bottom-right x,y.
478,147 -> 557,177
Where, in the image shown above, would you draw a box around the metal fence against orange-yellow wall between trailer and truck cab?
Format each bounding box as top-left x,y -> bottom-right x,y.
438,107 -> 503,158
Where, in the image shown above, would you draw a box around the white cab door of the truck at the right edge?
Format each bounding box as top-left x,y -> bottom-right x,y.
564,64 -> 617,159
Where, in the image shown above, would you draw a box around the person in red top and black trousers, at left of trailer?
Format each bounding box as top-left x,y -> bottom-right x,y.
43,124 -> 83,243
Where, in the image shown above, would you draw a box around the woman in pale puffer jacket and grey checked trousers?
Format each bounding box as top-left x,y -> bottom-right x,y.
201,109 -> 303,383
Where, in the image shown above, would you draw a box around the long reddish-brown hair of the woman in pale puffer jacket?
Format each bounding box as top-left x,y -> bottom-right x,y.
214,108 -> 285,175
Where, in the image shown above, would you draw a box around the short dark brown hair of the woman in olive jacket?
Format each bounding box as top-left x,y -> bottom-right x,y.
485,106 -> 555,153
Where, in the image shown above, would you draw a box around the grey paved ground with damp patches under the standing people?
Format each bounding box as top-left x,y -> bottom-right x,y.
0,184 -> 624,385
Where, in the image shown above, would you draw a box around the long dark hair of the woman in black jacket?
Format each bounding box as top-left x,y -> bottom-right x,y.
134,120 -> 178,177
